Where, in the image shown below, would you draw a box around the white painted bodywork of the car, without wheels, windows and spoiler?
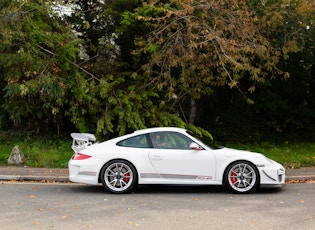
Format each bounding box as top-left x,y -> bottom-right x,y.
69,127 -> 285,191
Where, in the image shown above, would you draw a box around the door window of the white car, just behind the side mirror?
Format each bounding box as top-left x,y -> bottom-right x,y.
150,132 -> 193,149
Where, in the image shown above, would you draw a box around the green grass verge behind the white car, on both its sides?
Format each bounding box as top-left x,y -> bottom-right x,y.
0,131 -> 315,168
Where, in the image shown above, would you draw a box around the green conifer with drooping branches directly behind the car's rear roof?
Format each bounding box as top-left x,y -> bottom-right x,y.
67,0 -> 210,138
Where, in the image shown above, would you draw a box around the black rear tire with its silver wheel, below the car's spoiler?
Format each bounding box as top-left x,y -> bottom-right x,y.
101,160 -> 138,194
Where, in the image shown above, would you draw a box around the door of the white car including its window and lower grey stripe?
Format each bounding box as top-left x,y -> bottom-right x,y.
149,132 -> 215,184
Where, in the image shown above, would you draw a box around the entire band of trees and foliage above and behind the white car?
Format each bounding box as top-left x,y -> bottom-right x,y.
0,0 -> 315,141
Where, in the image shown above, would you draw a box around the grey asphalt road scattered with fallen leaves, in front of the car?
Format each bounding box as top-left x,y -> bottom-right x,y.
0,182 -> 315,230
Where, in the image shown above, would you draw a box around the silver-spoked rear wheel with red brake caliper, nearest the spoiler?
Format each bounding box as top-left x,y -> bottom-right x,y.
102,161 -> 135,193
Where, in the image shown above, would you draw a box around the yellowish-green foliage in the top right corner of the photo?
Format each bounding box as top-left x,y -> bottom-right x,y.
257,0 -> 315,59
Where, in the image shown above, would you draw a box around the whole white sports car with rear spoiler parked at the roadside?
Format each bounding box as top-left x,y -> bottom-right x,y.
69,127 -> 285,193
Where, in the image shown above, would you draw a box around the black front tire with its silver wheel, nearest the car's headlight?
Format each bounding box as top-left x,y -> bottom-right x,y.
224,161 -> 260,193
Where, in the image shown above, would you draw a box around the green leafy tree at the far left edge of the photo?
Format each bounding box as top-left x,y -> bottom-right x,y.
0,0 -> 78,130
